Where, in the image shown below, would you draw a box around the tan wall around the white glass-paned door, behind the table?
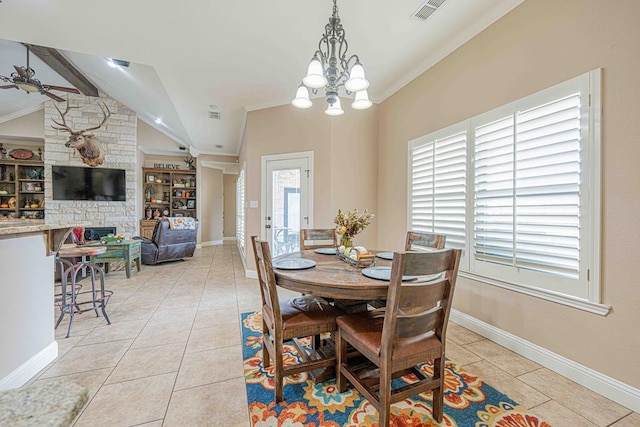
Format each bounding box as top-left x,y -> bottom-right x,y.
240,100 -> 378,270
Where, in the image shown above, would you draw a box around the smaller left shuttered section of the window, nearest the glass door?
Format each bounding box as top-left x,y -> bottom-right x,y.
409,127 -> 467,258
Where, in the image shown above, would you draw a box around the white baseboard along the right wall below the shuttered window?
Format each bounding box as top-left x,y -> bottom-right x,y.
450,309 -> 640,412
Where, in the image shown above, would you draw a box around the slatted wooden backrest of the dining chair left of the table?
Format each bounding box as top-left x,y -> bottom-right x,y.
251,236 -> 282,328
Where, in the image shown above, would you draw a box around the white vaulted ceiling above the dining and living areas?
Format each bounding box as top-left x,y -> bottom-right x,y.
0,0 -> 523,155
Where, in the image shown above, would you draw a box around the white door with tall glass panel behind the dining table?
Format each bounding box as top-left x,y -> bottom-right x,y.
263,153 -> 311,257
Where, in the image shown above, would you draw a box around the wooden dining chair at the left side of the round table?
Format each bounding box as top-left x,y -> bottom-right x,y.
251,236 -> 343,402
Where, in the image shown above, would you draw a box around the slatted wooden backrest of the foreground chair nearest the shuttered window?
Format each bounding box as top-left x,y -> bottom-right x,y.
381,249 -> 461,353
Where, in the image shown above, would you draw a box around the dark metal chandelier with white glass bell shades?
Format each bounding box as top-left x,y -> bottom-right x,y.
291,0 -> 371,116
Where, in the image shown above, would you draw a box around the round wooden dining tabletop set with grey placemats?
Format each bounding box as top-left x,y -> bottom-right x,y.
273,250 -> 391,301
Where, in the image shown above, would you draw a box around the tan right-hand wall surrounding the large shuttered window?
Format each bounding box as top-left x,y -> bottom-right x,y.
377,0 -> 640,388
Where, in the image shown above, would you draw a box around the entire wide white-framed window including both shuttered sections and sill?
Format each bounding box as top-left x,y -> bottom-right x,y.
408,70 -> 605,314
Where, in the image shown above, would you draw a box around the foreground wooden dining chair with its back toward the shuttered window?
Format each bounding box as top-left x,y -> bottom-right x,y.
336,249 -> 461,427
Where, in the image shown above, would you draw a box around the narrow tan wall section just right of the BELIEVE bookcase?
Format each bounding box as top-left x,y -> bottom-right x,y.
198,168 -> 224,244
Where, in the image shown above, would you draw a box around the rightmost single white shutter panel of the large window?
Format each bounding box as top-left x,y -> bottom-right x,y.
515,93 -> 581,278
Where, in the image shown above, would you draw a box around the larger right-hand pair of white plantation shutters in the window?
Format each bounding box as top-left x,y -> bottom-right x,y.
474,93 -> 581,278
